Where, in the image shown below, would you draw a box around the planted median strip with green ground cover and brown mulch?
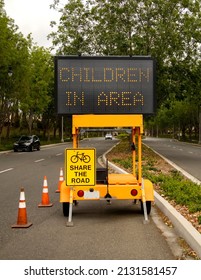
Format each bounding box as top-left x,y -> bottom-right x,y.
107,139 -> 201,233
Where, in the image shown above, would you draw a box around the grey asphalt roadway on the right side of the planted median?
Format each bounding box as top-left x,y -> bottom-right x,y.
143,137 -> 201,181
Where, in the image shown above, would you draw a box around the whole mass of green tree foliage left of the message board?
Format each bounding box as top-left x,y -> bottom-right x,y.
0,1 -> 54,138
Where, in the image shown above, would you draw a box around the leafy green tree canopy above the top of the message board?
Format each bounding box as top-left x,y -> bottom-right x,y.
50,0 -> 201,58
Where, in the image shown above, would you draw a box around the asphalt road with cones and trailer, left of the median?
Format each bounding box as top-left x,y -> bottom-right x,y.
0,138 -> 175,260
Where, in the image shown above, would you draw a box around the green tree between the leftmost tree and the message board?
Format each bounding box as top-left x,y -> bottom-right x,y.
19,46 -> 53,133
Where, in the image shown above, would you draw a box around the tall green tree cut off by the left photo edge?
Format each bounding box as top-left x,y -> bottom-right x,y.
0,1 -> 29,137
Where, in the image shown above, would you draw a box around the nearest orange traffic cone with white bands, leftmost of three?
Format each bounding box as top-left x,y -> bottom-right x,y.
11,188 -> 32,228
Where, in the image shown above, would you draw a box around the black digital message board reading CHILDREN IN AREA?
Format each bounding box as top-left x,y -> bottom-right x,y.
55,56 -> 155,114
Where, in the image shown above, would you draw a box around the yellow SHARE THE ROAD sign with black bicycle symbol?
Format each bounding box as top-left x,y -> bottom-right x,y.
65,148 -> 96,186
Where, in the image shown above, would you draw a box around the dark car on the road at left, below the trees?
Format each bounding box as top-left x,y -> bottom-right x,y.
13,135 -> 40,152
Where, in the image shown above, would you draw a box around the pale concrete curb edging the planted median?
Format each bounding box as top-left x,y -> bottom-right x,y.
102,149 -> 201,258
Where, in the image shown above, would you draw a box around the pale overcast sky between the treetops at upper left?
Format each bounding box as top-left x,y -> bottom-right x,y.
4,0 -> 60,47
